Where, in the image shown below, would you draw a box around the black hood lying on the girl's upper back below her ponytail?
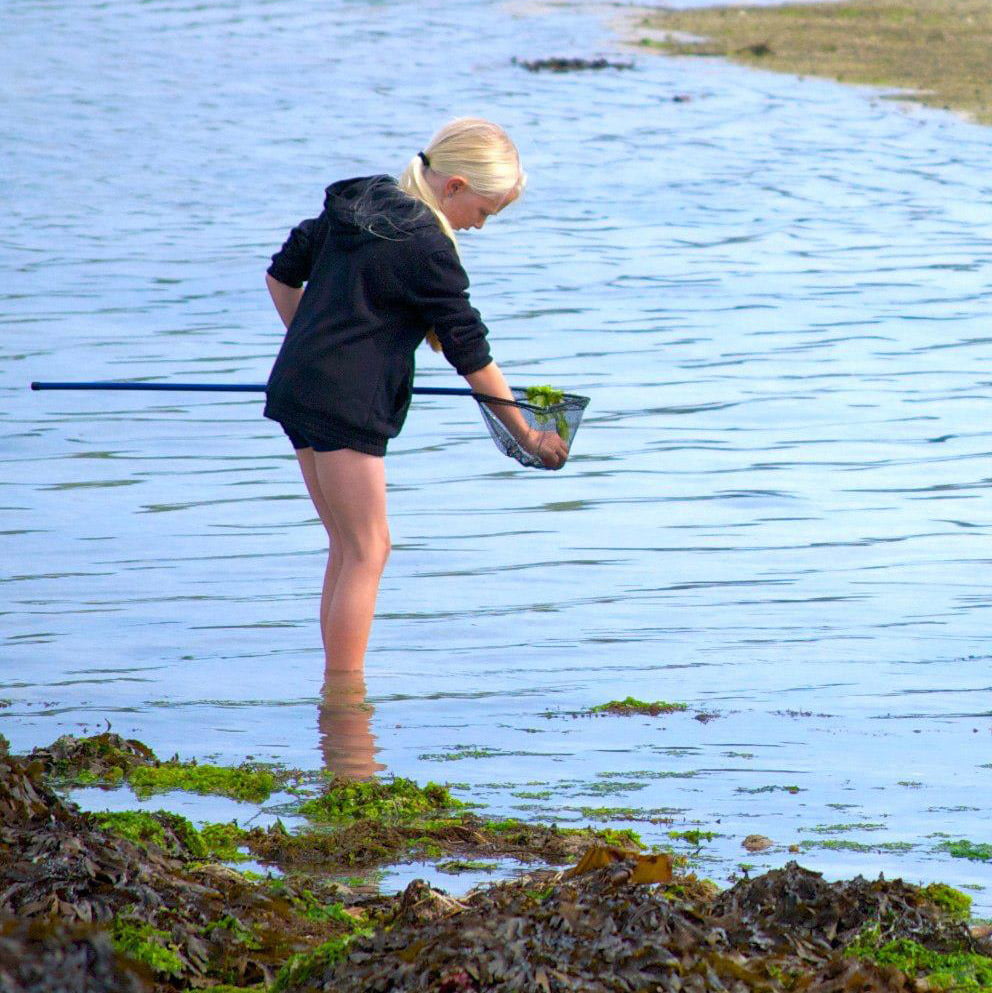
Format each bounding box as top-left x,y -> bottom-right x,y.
324,176 -> 438,246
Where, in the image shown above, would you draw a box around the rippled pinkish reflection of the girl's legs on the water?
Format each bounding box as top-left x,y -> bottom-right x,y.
317,669 -> 386,779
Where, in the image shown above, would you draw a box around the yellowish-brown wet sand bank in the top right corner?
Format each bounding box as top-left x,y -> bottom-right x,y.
635,0 -> 992,124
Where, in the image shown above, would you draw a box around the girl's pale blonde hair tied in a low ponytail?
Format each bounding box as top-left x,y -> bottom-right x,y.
399,117 -> 527,351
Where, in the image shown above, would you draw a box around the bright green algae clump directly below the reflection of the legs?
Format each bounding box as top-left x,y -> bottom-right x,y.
299,777 -> 465,823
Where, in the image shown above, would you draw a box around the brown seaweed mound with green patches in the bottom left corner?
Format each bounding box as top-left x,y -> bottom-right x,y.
0,732 -> 362,993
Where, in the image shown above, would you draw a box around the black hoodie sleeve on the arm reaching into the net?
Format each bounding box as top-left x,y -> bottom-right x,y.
410,248 -> 492,376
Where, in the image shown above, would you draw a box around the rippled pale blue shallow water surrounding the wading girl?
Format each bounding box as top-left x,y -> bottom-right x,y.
0,0 -> 992,914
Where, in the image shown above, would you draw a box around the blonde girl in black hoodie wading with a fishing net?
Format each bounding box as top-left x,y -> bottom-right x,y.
265,118 -> 568,671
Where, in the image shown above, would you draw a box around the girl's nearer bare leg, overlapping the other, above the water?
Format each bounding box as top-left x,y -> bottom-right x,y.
308,448 -> 390,670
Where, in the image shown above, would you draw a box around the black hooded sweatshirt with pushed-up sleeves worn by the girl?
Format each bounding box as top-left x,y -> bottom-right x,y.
265,176 -> 492,455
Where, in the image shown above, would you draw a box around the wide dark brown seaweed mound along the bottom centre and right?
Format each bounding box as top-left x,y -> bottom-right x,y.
287,860 -> 992,993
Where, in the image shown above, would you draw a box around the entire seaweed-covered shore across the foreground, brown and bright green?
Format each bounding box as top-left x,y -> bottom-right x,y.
0,733 -> 992,993
